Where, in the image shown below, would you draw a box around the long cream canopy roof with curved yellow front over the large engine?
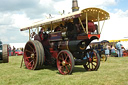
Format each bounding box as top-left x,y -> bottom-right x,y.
20,8 -> 110,31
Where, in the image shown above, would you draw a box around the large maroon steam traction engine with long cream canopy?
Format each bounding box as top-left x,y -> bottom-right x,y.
21,0 -> 109,75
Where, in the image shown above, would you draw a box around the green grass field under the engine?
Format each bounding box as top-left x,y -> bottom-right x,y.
0,56 -> 128,85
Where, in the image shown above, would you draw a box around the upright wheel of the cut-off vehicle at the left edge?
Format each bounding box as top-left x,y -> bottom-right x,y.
2,44 -> 9,63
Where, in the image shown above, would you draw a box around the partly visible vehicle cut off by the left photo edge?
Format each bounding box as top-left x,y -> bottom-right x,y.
0,41 -> 9,63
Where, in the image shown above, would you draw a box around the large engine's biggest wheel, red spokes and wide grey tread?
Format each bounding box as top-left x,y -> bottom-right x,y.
24,40 -> 44,70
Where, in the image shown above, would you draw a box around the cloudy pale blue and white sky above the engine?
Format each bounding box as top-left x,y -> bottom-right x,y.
0,0 -> 128,44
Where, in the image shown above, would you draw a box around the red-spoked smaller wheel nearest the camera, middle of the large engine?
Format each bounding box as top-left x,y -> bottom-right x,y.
57,50 -> 74,75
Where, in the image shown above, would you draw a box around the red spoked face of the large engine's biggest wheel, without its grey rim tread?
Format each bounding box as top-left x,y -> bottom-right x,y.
24,42 -> 37,70
